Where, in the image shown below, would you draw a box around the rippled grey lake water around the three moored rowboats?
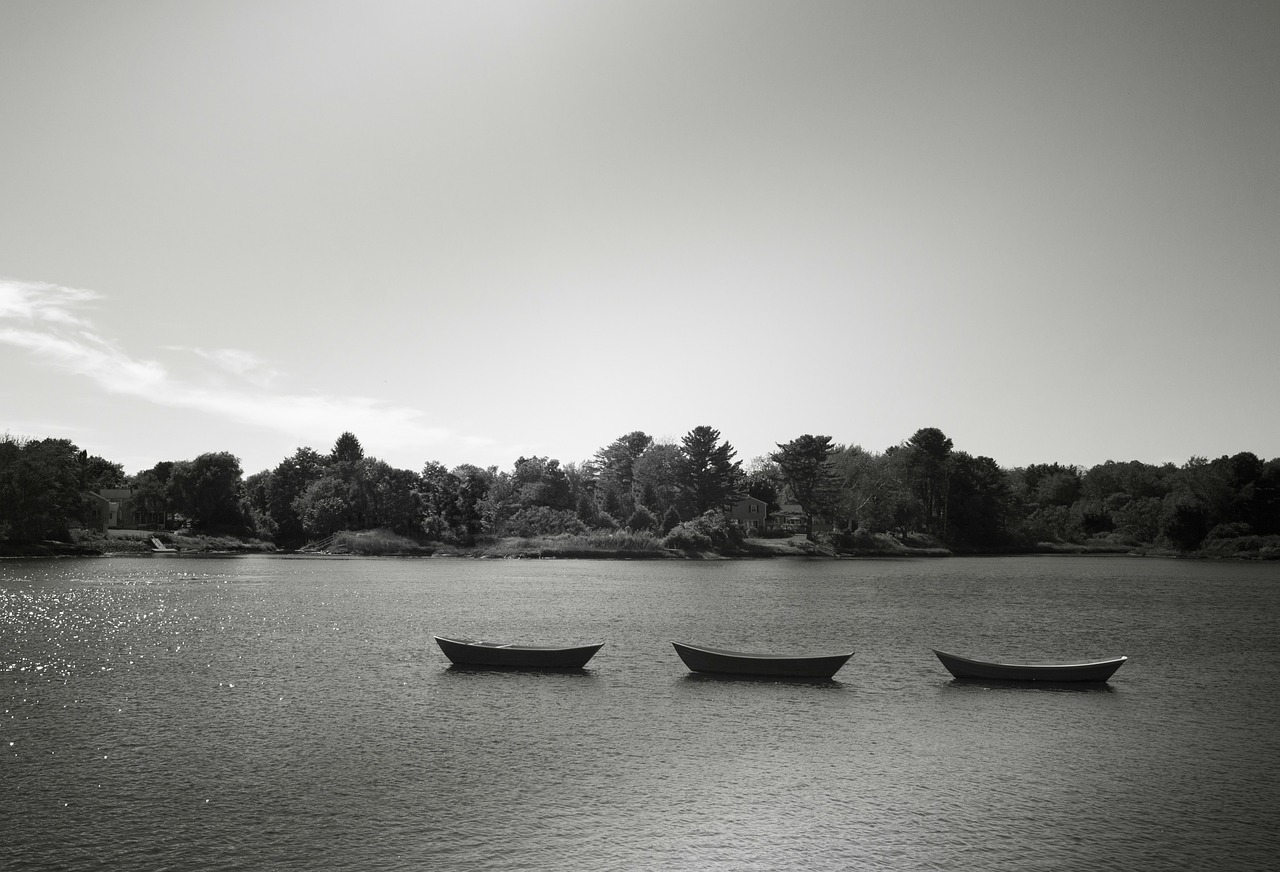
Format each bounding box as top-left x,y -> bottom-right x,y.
0,556 -> 1280,872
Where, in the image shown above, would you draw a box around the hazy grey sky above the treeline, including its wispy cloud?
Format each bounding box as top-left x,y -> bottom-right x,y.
0,0 -> 1280,475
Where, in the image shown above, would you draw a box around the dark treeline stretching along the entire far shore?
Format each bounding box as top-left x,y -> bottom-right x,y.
0,426 -> 1280,552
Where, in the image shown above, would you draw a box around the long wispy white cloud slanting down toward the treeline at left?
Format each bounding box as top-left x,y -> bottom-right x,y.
0,279 -> 457,448
